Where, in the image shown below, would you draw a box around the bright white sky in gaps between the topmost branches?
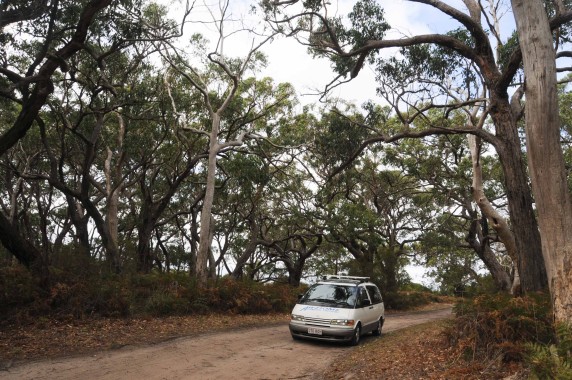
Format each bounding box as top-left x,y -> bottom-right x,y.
163,0 -> 462,105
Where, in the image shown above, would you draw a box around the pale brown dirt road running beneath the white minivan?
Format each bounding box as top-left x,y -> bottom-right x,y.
0,308 -> 451,380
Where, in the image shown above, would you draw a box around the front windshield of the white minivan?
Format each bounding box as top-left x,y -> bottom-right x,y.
299,284 -> 357,309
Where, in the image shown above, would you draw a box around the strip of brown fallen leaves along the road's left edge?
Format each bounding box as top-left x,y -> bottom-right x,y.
0,314 -> 289,362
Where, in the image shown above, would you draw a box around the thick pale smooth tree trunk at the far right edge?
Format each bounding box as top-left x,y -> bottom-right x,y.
512,0 -> 572,323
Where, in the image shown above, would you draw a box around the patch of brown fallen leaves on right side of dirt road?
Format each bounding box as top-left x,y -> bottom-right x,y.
320,321 -> 526,380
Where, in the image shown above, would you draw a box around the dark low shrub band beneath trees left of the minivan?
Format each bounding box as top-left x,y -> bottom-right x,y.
0,267 -> 301,319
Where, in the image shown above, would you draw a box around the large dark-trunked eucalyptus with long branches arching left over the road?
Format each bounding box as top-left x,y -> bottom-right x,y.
264,0 -> 572,291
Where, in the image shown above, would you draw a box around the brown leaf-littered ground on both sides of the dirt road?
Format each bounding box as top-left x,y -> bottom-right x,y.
0,304 -> 526,380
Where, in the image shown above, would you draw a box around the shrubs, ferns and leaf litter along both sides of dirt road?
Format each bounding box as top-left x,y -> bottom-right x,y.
0,267 -> 572,379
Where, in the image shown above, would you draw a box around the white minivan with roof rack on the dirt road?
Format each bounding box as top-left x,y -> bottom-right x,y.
290,275 -> 385,345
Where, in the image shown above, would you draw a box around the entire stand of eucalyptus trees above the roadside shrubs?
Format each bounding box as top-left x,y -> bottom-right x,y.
0,0 -> 572,322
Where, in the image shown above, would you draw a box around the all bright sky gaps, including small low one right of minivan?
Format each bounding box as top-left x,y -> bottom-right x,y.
163,0 -> 492,286
